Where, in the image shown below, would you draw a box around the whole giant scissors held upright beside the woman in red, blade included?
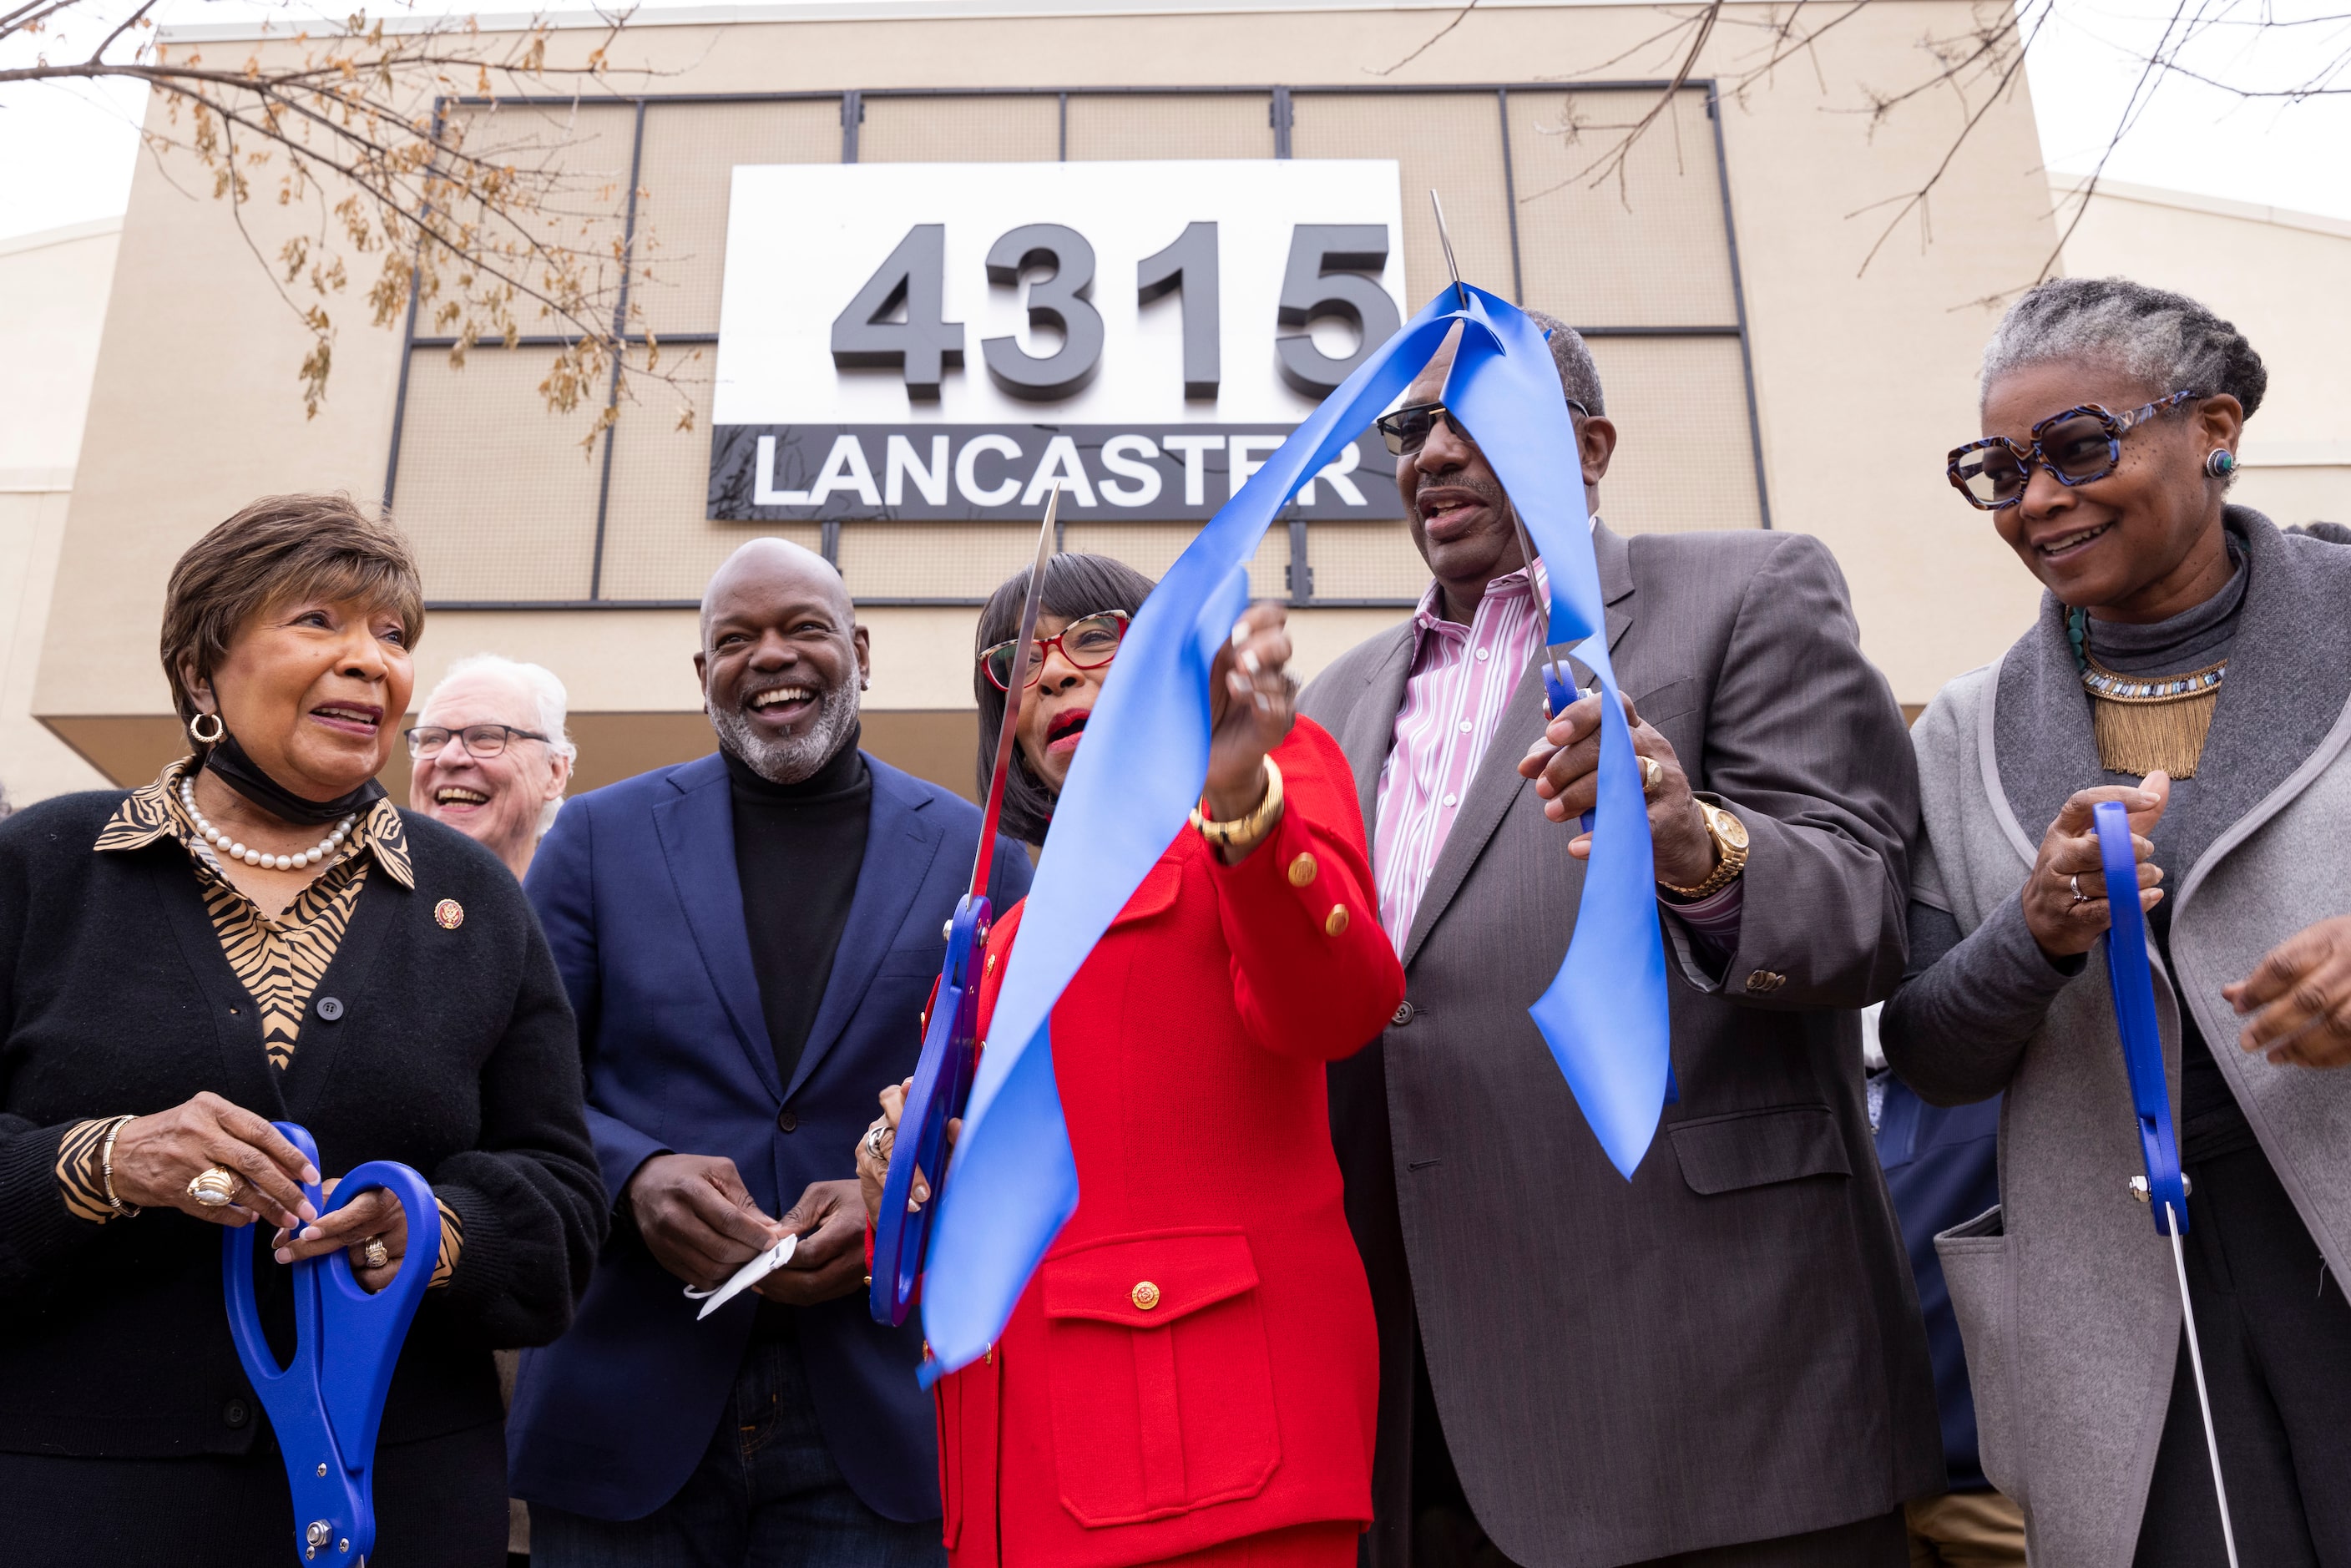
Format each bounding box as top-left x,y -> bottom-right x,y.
867,484 -> 1060,1328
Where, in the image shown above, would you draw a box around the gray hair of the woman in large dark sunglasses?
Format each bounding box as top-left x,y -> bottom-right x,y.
1977,277 -> 2268,418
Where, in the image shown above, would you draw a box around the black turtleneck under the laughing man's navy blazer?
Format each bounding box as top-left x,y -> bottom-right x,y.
724,731 -> 875,1089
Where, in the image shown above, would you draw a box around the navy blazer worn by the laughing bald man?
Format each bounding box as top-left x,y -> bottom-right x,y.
508,755 -> 1029,1521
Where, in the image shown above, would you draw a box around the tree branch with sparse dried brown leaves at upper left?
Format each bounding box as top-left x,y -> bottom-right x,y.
0,0 -> 691,452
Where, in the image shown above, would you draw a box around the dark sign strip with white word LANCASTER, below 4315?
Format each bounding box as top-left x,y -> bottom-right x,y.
710,426 -> 1403,522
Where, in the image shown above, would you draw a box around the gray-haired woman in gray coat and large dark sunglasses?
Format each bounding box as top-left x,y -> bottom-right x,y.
1883,277 -> 2351,1568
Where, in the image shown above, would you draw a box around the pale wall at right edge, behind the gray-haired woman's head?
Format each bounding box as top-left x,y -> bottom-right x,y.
2050,174 -> 2351,527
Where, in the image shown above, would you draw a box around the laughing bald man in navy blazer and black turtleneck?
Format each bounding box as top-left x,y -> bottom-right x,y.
508,539 -> 1029,1568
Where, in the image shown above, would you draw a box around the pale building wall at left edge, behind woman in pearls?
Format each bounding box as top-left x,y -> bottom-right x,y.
0,219 -> 120,807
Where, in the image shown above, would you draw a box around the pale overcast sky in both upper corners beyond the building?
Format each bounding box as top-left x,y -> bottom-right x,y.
0,0 -> 2351,237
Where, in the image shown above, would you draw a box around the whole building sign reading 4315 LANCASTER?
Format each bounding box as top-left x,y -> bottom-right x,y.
708,159 -> 1406,522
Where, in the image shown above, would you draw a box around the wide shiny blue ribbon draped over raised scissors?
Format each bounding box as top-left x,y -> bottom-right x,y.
922,285 -> 1669,1383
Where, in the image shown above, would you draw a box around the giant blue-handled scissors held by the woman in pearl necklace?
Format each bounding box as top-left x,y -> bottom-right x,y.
221,1121 -> 440,1563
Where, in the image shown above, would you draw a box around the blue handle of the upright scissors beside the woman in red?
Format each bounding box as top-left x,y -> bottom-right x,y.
867,893 -> 992,1328
